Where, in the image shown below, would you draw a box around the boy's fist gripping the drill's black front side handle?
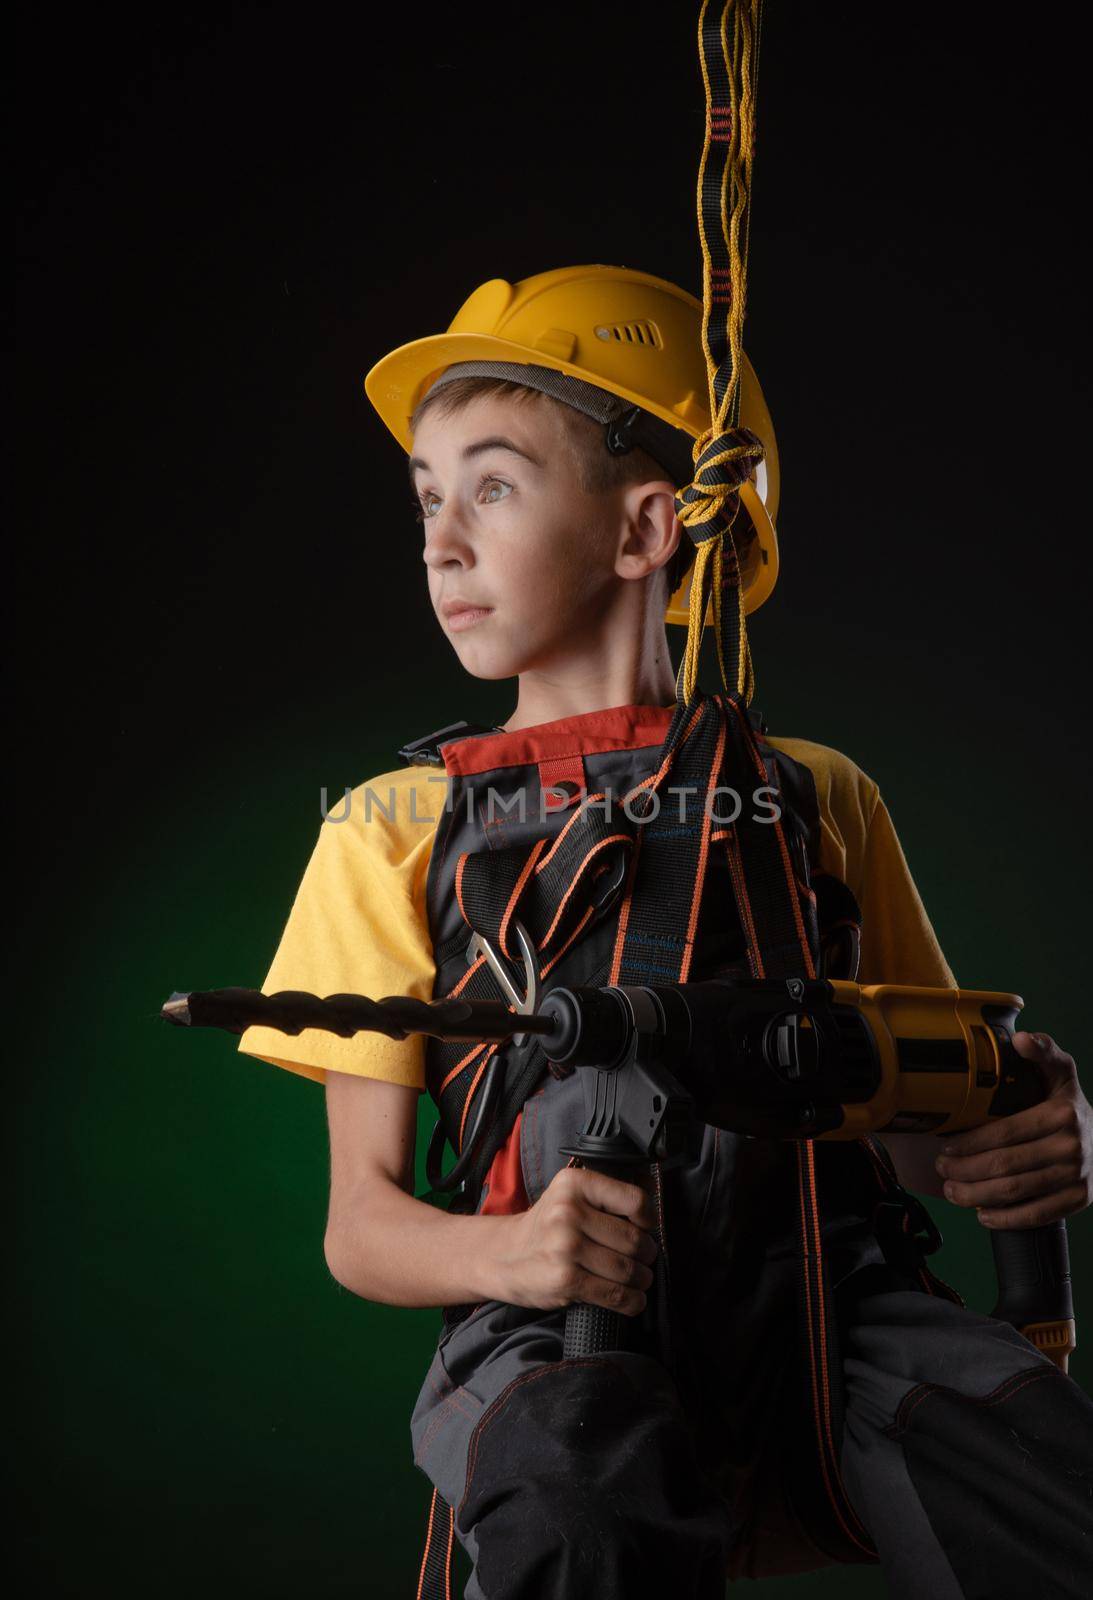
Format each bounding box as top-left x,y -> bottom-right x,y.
496,1166 -> 658,1317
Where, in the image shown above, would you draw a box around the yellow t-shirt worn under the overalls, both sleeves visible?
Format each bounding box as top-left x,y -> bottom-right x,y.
238,738 -> 955,1090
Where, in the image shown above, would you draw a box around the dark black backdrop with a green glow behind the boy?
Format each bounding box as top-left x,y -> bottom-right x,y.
8,0 -> 1093,1600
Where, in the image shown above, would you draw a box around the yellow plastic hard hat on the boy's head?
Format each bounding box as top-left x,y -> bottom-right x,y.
365,266 -> 778,626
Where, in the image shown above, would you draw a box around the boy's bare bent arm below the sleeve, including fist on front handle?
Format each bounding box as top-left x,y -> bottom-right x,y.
316,1072 -> 656,1317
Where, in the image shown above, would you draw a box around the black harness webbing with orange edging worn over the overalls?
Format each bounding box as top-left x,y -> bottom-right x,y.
409,694 -> 946,1600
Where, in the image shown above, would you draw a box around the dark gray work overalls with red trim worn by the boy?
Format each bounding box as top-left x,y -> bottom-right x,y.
403,707 -> 1093,1600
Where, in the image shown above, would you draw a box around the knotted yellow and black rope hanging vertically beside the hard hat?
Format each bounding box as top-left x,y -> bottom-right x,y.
675,0 -> 763,706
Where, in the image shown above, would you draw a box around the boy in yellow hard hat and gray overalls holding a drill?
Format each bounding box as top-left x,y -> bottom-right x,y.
240,267 -> 1093,1600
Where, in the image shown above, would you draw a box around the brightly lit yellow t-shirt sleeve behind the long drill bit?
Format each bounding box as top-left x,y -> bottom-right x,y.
238,774 -> 435,1090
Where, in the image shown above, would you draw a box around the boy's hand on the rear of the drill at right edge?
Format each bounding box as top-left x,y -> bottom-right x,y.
936,1032 -> 1093,1227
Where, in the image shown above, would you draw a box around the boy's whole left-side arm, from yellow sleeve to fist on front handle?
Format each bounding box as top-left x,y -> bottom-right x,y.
238,768 -> 656,1315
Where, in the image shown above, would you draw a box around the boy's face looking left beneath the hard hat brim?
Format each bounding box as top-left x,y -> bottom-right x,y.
410,395 -> 649,678
